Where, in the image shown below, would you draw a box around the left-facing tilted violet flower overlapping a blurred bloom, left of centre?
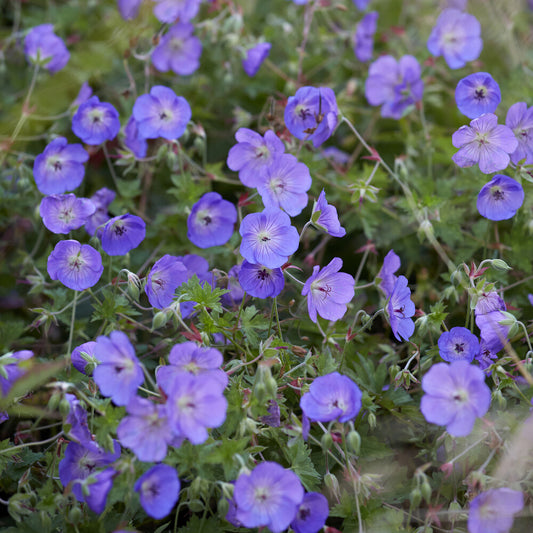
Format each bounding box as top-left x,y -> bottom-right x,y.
144,254 -> 189,309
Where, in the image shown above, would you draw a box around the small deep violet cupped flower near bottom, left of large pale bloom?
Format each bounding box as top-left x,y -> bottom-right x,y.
133,464 -> 180,520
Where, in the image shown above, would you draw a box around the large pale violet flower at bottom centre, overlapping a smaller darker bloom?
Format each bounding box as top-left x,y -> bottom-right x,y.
233,461 -> 304,533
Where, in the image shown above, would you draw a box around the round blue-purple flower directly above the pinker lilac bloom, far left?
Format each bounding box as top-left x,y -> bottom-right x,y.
33,137 -> 89,194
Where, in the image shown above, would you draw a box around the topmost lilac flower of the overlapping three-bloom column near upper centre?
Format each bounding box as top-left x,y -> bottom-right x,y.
227,128 -> 285,187
